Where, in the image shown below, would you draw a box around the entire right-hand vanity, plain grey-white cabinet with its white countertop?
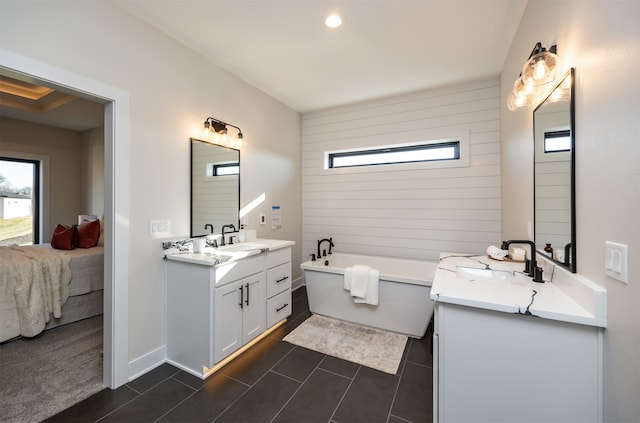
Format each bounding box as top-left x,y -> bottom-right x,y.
431,255 -> 606,423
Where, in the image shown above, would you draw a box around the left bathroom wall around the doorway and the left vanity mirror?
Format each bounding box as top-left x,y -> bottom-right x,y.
0,2 -> 301,372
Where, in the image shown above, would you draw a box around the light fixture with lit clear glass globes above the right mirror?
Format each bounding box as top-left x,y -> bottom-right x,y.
507,43 -> 558,111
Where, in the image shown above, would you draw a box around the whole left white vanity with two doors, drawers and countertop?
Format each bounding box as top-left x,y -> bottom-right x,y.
166,240 -> 293,378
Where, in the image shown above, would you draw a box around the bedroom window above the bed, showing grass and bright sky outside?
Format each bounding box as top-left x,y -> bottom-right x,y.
0,157 -> 40,245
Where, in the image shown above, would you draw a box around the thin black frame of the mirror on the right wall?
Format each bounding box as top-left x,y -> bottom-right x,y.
533,68 -> 577,273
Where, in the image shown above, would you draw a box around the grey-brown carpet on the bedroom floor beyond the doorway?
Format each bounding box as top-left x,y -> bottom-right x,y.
0,316 -> 104,422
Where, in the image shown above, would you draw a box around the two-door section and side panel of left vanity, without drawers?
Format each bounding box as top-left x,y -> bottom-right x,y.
167,254 -> 266,377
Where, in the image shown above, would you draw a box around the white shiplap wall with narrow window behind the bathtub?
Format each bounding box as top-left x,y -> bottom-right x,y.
302,78 -> 501,261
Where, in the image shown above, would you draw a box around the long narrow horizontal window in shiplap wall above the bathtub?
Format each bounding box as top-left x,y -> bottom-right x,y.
328,141 -> 460,169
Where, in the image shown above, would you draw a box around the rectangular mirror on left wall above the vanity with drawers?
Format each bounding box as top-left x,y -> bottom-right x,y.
191,138 -> 240,237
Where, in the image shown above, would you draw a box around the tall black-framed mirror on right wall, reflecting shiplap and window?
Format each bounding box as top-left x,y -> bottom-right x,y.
533,68 -> 576,273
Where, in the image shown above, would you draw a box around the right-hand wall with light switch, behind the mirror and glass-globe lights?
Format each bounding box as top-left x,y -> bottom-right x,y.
501,0 -> 640,422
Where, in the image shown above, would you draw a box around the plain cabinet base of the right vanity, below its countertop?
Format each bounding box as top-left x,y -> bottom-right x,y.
433,303 -> 603,423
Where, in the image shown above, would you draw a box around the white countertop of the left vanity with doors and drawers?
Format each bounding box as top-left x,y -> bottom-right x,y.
165,239 -> 295,266
